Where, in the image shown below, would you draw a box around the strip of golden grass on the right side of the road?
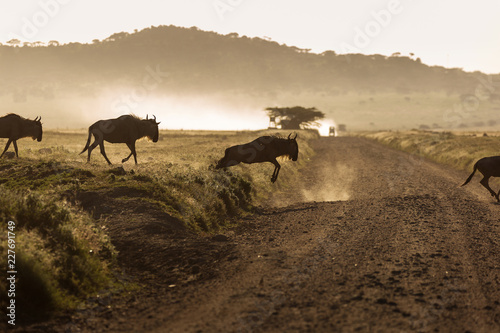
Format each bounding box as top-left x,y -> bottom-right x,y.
360,131 -> 500,176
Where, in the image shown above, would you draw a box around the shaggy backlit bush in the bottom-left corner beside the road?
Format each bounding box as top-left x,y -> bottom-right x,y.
0,186 -> 115,321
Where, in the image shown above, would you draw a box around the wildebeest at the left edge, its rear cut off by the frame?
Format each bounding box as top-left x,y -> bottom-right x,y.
0,113 -> 43,158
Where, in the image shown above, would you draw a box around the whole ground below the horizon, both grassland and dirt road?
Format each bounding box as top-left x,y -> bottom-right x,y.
0,130 -> 500,332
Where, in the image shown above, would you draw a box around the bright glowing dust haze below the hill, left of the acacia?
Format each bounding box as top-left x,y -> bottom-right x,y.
34,90 -> 269,131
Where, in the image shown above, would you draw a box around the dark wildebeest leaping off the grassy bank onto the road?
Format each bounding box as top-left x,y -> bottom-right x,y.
215,134 -> 299,183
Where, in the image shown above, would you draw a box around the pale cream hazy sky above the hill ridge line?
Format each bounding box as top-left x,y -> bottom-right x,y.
0,0 -> 500,73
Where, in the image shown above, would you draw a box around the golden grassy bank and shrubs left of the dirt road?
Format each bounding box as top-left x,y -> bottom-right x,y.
0,127 -> 317,318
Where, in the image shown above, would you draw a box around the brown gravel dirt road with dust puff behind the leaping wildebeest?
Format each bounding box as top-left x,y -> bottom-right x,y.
37,137 -> 500,332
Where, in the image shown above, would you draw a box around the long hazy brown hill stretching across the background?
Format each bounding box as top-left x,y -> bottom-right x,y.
0,26 -> 500,130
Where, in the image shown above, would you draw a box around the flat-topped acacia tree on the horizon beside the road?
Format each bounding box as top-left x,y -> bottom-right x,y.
265,106 -> 325,129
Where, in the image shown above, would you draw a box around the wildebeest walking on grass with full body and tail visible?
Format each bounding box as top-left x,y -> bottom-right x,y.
80,115 -> 159,165
